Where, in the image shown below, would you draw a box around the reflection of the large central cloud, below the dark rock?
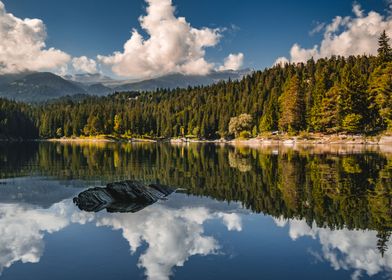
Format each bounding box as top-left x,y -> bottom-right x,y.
96,203 -> 242,280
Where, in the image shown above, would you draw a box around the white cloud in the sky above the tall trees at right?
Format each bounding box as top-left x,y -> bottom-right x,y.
275,4 -> 392,63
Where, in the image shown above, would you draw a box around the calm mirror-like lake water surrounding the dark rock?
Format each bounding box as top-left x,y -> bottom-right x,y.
0,143 -> 392,280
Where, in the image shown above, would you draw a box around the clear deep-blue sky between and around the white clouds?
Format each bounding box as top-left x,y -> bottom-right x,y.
2,0 -> 388,78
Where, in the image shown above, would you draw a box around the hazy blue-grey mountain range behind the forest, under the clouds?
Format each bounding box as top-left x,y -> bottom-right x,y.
0,69 -> 252,102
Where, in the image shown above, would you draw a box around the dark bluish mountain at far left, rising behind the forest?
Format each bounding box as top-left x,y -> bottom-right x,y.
0,72 -> 87,102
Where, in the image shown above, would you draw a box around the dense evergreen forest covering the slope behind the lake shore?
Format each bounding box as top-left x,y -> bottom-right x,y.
0,32 -> 392,139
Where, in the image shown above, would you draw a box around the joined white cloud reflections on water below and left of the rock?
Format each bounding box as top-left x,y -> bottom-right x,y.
0,190 -> 242,280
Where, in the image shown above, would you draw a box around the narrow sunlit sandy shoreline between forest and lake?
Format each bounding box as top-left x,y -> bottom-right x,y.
39,134 -> 392,146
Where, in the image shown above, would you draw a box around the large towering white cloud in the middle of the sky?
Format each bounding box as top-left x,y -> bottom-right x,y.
98,0 -> 243,79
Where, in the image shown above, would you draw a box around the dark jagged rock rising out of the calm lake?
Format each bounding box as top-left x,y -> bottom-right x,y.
73,181 -> 174,213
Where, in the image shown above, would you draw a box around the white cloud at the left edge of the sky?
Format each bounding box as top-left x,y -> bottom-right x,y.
0,1 -> 70,74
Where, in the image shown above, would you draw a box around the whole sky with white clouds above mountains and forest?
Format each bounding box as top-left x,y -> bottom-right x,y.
0,0 -> 392,80
